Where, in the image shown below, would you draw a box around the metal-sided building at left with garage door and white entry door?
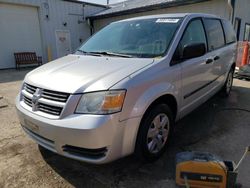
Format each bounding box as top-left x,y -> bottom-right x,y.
0,0 -> 106,69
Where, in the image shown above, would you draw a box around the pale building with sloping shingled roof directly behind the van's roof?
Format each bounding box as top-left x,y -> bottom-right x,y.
89,0 -> 250,41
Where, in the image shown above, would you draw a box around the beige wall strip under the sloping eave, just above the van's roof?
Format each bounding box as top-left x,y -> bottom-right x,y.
94,0 -> 229,31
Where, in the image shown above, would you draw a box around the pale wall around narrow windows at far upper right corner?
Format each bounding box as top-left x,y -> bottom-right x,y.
234,0 -> 250,41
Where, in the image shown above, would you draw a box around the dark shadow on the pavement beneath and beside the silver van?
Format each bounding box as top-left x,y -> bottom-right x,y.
39,87 -> 250,188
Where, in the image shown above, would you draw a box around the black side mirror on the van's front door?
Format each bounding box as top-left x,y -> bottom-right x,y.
181,43 -> 206,60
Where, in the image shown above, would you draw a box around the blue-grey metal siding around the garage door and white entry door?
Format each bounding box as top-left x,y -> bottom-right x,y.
0,0 -> 103,67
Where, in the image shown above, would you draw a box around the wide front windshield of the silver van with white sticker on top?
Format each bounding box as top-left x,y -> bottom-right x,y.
79,18 -> 181,58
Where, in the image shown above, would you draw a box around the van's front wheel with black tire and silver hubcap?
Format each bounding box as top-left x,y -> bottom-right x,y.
135,104 -> 174,161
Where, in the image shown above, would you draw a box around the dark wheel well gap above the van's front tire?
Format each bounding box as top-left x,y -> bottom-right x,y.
145,94 -> 177,119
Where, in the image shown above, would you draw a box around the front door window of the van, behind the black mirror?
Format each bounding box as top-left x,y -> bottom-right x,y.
176,19 -> 207,57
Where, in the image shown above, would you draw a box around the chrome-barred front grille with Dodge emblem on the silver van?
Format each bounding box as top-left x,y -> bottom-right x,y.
22,83 -> 70,117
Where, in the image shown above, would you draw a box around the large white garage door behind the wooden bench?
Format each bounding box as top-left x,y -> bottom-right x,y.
0,3 -> 42,69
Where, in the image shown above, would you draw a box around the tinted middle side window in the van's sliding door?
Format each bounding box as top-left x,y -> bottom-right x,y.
204,18 -> 225,51
